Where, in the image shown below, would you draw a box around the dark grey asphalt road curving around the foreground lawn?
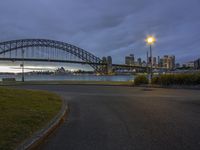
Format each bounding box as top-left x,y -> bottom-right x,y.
15,85 -> 200,150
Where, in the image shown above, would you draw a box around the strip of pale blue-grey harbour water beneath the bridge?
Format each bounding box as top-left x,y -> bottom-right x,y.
0,74 -> 134,81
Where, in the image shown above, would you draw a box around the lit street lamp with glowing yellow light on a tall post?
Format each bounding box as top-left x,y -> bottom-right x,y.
146,36 -> 156,83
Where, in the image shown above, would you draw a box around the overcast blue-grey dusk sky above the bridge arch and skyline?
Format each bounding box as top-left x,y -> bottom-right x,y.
0,0 -> 200,66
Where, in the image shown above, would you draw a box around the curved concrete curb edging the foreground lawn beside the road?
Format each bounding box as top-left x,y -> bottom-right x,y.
16,100 -> 69,150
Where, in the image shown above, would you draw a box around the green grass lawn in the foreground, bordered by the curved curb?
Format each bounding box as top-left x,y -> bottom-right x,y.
0,88 -> 62,150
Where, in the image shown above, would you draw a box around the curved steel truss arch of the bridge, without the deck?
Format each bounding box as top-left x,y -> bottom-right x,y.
0,39 -> 102,72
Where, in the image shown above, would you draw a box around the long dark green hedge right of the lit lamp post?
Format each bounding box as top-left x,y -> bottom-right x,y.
152,73 -> 200,86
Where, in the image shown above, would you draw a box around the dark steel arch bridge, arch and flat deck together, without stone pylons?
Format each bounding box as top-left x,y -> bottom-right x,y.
0,39 -> 103,73
